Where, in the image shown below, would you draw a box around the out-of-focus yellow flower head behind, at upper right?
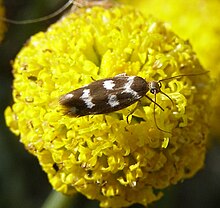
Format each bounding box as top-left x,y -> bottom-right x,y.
121,0 -> 220,135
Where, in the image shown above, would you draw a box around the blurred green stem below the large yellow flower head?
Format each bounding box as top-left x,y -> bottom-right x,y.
41,191 -> 78,208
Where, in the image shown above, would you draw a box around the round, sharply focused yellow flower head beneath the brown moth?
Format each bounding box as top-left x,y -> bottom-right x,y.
5,6 -> 210,207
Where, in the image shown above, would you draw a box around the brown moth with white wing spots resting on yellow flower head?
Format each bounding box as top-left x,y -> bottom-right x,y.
59,72 -> 207,133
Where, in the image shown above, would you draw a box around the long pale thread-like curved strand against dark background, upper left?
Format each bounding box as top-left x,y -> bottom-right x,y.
0,0 -> 73,25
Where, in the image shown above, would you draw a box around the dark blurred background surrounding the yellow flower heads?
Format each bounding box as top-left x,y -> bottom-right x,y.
0,0 -> 220,208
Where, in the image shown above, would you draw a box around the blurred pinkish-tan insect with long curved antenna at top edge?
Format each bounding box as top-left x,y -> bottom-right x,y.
0,0 -> 115,25
